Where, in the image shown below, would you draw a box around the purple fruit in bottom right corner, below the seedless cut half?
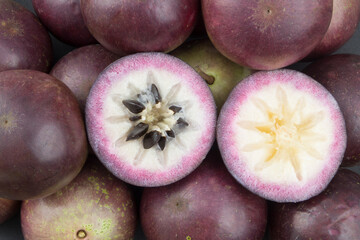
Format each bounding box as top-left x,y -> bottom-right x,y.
269,169 -> 360,240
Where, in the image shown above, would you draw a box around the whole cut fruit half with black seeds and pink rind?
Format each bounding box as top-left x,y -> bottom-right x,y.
85,53 -> 216,186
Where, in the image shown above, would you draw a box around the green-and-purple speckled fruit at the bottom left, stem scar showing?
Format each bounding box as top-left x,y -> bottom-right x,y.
21,159 -> 137,240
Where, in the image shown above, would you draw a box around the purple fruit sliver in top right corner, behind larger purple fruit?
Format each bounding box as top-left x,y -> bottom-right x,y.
307,0 -> 360,59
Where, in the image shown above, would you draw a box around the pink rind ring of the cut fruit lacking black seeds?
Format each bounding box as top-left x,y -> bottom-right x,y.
217,70 -> 346,202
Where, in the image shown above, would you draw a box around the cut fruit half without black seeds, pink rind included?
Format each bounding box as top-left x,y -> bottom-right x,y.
217,70 -> 346,202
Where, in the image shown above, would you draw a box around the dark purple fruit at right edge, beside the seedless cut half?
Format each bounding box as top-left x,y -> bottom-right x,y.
303,54 -> 360,166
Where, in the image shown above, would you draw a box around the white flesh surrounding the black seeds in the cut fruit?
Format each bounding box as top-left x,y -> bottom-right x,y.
103,69 -> 207,171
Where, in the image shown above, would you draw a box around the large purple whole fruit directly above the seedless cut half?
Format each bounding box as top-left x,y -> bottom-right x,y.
201,0 -> 333,70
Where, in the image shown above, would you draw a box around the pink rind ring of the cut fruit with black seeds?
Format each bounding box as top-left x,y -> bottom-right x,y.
86,53 -> 216,186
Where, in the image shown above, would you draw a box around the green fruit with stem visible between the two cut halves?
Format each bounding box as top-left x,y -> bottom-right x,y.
171,39 -> 254,111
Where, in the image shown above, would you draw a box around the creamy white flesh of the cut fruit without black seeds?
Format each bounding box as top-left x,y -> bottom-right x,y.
233,83 -> 334,185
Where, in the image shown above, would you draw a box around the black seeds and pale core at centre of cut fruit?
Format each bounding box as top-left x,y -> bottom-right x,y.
122,84 -> 189,150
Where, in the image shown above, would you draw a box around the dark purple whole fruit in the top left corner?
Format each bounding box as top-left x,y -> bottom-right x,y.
0,0 -> 52,72
